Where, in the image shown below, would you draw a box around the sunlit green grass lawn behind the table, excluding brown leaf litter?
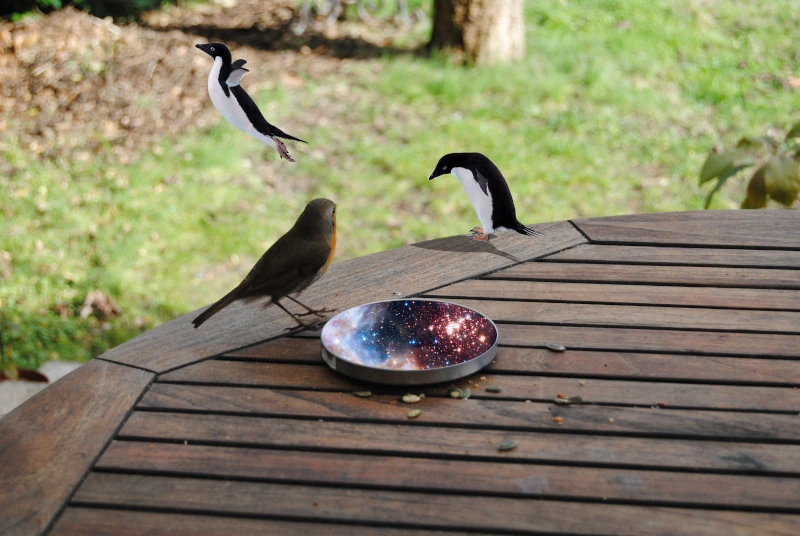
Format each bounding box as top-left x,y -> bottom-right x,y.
0,0 -> 800,366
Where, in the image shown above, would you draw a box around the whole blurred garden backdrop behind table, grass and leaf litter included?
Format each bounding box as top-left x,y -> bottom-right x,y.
0,0 -> 800,371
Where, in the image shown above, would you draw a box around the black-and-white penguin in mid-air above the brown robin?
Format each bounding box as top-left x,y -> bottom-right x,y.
195,43 -> 308,162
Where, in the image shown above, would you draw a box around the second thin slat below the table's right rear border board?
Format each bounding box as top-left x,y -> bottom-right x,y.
486,262 -> 800,290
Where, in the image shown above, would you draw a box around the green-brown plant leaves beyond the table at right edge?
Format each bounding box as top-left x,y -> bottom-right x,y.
700,121 -> 800,208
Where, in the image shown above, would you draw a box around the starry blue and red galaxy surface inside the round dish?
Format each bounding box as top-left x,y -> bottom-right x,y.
322,299 -> 497,370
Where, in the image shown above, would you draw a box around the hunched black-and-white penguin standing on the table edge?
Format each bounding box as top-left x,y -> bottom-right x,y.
428,153 -> 544,240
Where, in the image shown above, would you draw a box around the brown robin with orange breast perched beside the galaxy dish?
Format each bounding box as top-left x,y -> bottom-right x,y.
192,199 -> 336,328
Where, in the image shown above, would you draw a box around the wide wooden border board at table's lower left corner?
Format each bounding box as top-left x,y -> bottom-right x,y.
0,360 -> 153,535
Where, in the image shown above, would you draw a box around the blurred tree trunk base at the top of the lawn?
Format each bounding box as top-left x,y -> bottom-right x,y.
430,0 -> 525,65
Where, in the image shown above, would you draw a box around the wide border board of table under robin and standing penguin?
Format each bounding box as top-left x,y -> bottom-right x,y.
97,222 -> 585,372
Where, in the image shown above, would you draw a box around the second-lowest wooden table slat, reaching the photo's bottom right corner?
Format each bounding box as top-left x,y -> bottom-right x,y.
70,474 -> 800,535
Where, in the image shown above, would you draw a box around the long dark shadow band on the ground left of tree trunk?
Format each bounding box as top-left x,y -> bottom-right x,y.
142,21 -> 427,59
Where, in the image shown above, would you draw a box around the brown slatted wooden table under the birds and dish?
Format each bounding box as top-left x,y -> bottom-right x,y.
0,210 -> 800,536
